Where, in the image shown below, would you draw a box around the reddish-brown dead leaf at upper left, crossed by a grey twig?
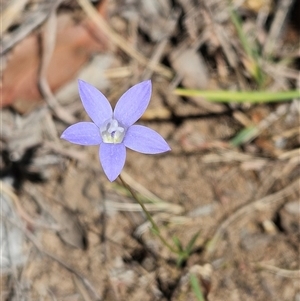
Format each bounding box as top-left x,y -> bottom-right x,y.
0,1 -> 108,107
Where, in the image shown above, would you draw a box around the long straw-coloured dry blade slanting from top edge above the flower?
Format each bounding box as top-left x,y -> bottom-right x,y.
77,0 -> 173,78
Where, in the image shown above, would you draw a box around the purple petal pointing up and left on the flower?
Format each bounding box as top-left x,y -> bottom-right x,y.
78,80 -> 113,127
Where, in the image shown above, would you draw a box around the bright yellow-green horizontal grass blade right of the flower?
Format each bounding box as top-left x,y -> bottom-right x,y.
174,89 -> 300,103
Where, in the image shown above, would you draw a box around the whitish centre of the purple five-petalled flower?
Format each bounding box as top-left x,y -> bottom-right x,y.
100,118 -> 125,143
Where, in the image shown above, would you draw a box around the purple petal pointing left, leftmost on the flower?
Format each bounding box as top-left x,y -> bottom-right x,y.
60,122 -> 102,145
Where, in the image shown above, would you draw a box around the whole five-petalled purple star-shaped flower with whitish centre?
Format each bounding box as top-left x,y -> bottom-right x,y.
61,80 -> 171,182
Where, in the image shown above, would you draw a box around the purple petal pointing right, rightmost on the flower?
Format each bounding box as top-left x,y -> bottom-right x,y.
123,125 -> 171,154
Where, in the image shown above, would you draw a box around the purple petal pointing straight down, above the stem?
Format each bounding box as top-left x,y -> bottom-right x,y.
99,143 -> 126,182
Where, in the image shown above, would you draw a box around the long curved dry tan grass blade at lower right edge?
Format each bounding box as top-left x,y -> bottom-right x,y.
206,178 -> 300,256
